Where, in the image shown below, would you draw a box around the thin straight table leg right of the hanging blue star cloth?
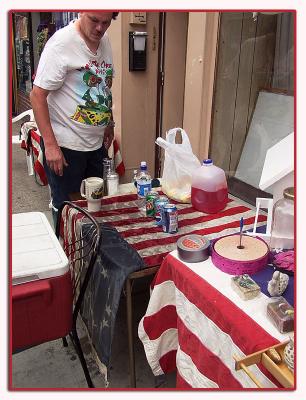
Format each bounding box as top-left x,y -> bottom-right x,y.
125,278 -> 136,387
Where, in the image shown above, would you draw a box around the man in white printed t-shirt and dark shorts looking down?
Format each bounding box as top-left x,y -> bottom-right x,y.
30,12 -> 118,223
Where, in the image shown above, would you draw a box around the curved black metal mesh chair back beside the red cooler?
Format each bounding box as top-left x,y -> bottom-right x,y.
56,201 -> 102,323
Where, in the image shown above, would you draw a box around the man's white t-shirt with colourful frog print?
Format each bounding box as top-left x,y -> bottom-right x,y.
34,22 -> 114,151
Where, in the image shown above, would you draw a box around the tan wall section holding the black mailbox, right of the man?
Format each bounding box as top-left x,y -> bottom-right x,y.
112,12 -> 159,183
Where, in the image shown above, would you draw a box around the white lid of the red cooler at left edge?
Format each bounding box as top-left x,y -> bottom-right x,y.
12,212 -> 69,285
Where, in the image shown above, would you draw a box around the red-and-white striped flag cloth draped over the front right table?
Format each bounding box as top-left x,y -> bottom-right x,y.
138,250 -> 288,390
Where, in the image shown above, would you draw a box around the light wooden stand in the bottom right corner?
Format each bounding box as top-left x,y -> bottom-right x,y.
234,340 -> 294,388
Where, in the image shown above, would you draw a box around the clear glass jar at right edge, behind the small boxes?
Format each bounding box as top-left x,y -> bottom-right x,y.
270,187 -> 294,251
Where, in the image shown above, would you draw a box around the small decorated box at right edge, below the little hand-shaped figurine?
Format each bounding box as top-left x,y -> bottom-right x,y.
267,296 -> 294,333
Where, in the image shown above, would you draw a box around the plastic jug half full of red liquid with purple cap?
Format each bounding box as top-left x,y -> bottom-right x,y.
191,159 -> 228,214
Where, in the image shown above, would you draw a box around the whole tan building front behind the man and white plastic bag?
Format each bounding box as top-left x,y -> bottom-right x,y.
108,12 -> 219,182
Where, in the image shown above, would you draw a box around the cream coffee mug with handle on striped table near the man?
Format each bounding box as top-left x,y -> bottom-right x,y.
80,177 -> 104,211
